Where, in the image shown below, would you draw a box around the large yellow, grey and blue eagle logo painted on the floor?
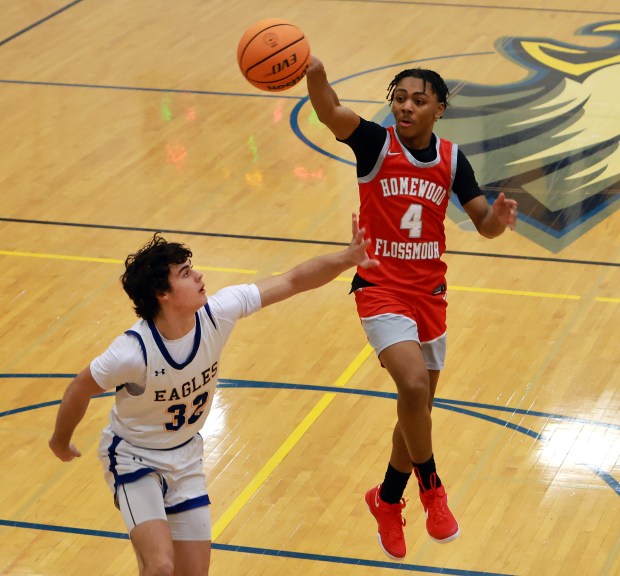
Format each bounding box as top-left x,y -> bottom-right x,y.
434,22 -> 620,252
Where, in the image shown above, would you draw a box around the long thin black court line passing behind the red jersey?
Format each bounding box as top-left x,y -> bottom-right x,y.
0,217 -> 620,268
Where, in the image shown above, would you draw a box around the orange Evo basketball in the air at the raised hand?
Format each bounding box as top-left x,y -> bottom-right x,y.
237,18 -> 310,92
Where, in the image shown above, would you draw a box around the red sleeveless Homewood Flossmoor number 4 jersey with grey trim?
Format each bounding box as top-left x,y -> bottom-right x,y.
358,126 -> 457,294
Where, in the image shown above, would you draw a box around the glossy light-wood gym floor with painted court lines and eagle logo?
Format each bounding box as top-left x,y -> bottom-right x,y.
0,0 -> 620,576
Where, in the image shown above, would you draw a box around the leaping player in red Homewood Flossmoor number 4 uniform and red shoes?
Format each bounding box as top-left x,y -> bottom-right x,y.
306,56 -> 517,560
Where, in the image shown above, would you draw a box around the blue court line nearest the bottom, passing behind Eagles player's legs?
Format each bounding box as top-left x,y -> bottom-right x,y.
0,519 -> 510,576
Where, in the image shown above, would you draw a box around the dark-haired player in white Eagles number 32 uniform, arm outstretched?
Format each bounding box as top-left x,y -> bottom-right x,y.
49,215 -> 378,576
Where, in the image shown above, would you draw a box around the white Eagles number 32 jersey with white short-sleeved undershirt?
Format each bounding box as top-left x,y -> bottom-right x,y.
90,284 -> 261,450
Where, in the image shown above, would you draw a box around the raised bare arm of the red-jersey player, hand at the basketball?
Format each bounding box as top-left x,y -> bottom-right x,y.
306,56 -> 360,140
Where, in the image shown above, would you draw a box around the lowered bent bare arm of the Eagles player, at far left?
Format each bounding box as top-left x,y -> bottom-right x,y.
49,366 -> 104,462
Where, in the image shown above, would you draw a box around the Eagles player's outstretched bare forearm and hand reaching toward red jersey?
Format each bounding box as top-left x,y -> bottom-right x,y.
256,214 -> 379,308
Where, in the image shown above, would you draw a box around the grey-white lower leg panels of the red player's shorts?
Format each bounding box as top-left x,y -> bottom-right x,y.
361,313 -> 447,370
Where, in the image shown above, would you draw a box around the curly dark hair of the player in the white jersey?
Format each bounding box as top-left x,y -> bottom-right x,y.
121,233 -> 192,320
